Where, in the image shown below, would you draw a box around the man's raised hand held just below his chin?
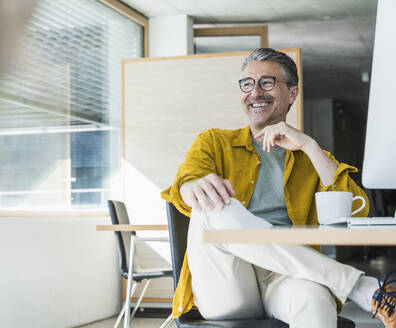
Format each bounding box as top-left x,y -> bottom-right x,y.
254,122 -> 315,152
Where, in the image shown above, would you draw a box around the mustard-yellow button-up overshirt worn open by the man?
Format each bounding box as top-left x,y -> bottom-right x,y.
161,126 -> 369,318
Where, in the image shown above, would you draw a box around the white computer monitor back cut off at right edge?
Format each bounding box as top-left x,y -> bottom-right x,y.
362,0 -> 396,189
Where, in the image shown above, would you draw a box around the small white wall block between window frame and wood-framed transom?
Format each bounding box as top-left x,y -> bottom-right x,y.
148,15 -> 194,57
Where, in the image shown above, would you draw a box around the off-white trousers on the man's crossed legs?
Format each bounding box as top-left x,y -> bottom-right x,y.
187,199 -> 363,328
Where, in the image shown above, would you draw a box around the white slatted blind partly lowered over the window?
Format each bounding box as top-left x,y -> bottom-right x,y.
0,0 -> 143,134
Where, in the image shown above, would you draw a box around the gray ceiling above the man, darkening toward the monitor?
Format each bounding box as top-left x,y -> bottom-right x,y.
124,0 -> 377,106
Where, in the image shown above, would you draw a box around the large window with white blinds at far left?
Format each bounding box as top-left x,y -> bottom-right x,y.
0,0 -> 144,209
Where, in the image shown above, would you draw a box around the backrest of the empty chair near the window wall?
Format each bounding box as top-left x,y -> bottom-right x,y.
107,200 -> 135,278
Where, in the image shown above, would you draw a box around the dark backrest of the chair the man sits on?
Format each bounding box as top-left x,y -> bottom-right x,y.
166,202 -> 190,289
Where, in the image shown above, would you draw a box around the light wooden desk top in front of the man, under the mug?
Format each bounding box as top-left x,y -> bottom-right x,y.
203,226 -> 396,245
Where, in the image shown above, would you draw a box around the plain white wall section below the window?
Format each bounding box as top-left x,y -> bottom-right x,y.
0,217 -> 122,328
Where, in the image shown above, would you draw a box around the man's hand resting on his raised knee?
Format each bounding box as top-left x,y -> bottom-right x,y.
180,173 -> 235,212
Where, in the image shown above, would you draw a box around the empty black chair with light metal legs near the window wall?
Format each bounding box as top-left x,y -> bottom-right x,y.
107,200 -> 172,328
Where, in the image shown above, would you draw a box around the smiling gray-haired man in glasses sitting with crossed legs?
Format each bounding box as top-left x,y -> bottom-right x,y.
162,48 -> 396,328
